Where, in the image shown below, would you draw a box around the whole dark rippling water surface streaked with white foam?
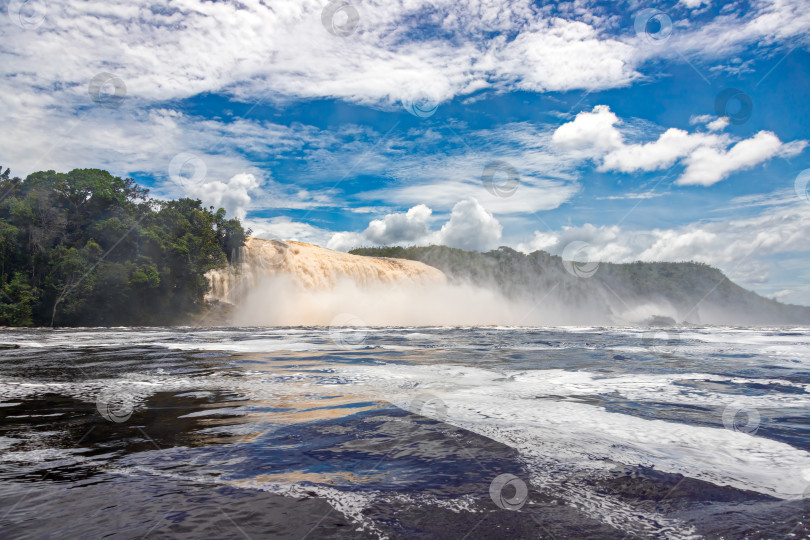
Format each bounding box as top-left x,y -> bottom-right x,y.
0,328 -> 810,538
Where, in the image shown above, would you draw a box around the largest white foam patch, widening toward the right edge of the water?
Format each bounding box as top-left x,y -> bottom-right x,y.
336,365 -> 810,499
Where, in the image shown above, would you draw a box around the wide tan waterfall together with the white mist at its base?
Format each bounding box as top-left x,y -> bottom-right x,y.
206,238 -> 592,326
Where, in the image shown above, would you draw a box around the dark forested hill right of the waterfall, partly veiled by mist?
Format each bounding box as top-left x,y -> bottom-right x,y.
351,246 -> 810,326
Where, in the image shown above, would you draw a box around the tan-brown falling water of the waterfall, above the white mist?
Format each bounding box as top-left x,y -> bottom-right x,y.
206,238 -> 446,304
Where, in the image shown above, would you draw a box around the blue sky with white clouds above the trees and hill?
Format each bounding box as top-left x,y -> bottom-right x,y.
0,0 -> 810,305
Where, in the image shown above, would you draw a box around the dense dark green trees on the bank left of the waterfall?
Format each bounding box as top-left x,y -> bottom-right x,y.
0,168 -> 250,326
